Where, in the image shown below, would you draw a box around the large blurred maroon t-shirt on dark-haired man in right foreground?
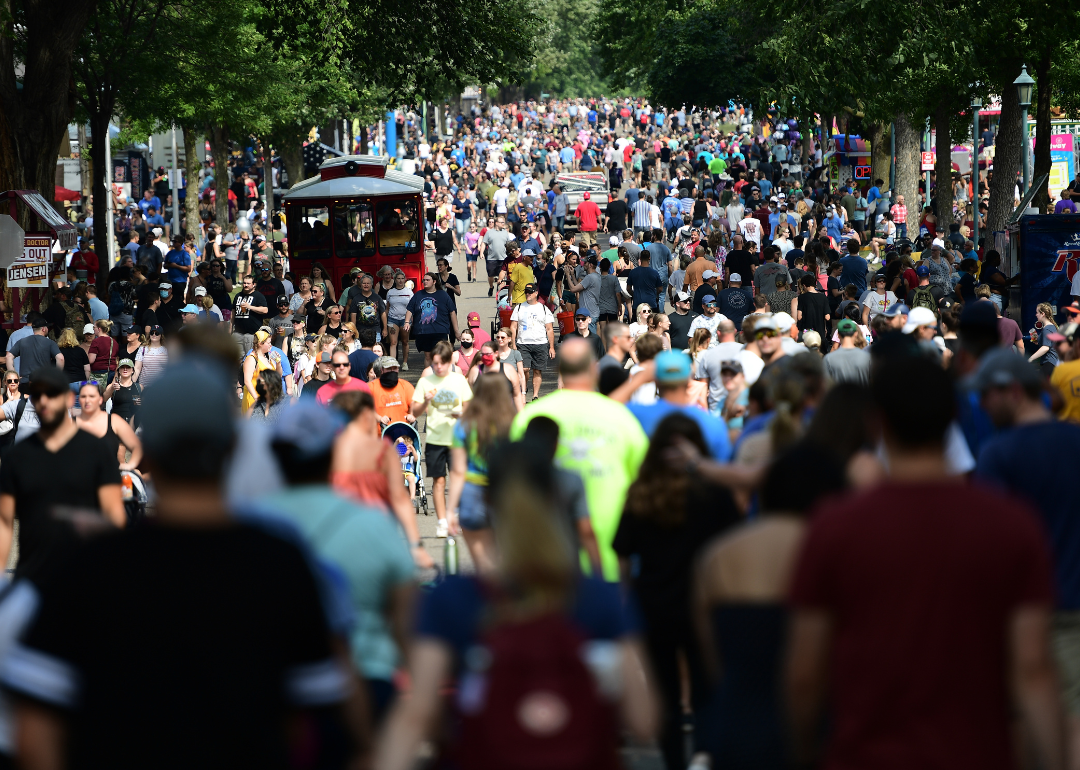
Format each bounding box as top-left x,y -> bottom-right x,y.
791,482 -> 1052,770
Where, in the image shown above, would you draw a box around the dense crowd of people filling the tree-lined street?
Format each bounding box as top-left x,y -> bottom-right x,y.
0,96 -> 1080,770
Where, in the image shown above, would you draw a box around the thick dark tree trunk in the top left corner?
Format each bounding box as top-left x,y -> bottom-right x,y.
0,0 -> 94,203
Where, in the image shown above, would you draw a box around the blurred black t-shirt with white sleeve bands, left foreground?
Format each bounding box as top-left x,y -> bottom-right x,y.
6,524 -> 348,770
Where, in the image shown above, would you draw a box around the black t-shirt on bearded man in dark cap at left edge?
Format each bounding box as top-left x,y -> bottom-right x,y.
0,431 -> 120,576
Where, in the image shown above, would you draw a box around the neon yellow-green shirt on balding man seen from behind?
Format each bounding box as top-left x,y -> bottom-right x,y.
510,390 -> 649,581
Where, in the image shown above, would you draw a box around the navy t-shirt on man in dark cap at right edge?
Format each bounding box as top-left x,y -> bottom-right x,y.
975,420 -> 1080,610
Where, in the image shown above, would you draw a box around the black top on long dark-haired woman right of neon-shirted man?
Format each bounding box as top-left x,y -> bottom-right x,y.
611,483 -> 742,634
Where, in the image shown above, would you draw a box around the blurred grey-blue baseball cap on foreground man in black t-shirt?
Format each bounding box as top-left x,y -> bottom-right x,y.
139,361 -> 237,457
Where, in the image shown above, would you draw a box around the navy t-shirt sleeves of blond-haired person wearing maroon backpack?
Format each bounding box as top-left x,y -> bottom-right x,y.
416,576 -> 638,666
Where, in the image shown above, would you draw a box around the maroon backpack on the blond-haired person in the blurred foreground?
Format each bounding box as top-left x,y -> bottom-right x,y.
456,600 -> 619,770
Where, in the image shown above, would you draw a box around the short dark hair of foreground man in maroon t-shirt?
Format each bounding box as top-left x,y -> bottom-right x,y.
870,356 -> 956,449
